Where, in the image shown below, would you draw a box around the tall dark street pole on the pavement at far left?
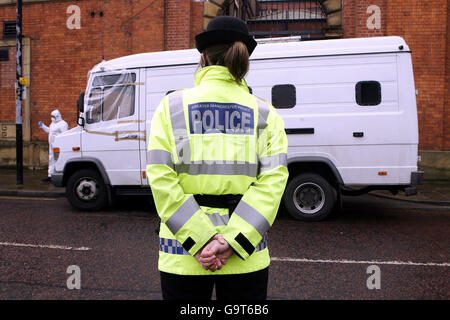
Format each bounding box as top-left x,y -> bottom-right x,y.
16,0 -> 23,185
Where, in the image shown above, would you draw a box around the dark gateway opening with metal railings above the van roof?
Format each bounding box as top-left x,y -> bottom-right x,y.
222,0 -> 327,39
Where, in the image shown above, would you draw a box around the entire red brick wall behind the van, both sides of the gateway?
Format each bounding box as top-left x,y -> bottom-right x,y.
0,0 -> 450,150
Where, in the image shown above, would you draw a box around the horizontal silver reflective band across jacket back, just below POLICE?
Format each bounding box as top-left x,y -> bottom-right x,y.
175,161 -> 258,178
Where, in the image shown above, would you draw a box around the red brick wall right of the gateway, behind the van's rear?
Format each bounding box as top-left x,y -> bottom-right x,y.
342,0 -> 450,150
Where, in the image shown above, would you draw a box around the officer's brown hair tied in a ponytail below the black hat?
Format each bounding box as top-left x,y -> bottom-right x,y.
200,41 -> 249,84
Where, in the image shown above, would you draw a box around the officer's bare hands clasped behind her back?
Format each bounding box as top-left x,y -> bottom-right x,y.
195,234 -> 234,272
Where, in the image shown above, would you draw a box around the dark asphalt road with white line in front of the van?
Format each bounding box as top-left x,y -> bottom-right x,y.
0,195 -> 450,300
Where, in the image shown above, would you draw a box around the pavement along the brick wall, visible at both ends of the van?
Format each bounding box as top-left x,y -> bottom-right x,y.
0,168 -> 450,206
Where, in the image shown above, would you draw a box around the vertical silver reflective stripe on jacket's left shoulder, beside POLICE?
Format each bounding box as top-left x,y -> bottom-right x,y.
168,90 -> 191,163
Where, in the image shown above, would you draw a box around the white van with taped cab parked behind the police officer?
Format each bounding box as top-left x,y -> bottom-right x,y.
52,37 -> 422,221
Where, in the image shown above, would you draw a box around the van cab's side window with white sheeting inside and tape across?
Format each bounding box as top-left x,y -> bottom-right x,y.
86,73 -> 136,123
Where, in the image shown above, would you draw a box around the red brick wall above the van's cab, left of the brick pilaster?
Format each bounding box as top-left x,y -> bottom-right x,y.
0,0 -> 166,140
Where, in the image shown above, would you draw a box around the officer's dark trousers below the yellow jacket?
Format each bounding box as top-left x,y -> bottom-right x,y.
160,268 -> 269,301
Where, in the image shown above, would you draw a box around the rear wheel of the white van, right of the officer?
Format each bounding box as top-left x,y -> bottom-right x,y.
283,173 -> 336,221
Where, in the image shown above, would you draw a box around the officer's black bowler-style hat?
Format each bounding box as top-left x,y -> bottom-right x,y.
195,16 -> 257,56
